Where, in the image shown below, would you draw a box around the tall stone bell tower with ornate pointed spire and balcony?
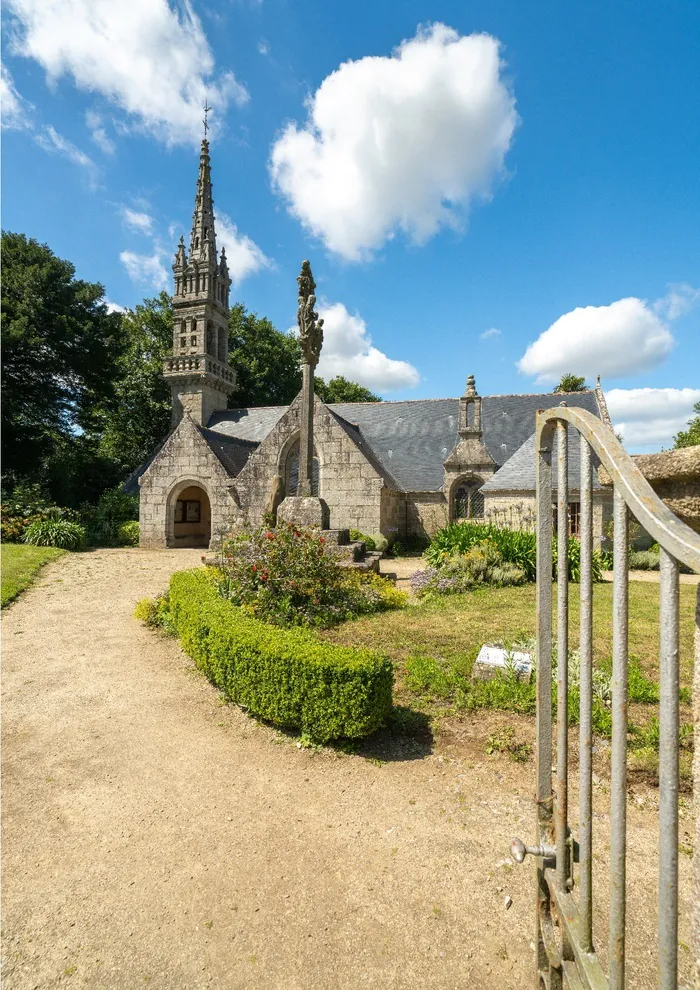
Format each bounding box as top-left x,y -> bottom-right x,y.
163,107 -> 236,429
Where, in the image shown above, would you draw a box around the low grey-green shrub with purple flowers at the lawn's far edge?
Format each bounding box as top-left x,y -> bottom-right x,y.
411,540 -> 525,598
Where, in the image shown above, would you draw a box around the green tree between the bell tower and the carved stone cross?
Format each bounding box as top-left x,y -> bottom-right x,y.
229,303 -> 301,409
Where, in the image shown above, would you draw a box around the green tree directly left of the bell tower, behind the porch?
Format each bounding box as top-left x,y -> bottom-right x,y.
100,292 -> 173,477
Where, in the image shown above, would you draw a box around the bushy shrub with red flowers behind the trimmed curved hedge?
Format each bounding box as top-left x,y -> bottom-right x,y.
219,523 -> 403,627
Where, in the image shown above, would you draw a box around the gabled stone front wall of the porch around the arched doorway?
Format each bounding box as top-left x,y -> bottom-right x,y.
139,416 -> 236,549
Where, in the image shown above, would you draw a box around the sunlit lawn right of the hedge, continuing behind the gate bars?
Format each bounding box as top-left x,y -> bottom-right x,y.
325,581 -> 697,687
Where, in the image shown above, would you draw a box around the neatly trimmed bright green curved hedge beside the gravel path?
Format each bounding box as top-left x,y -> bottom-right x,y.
169,570 -> 394,742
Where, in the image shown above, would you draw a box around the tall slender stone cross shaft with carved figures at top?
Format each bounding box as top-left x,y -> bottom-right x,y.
297,261 -> 323,496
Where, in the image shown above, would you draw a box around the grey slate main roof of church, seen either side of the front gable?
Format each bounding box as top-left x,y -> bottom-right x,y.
208,391 -> 600,491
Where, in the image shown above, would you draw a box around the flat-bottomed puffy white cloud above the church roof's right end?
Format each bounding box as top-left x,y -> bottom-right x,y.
518,297 -> 674,382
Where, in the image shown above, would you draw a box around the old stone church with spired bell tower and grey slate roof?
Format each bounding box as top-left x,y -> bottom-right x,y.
134,138 -> 610,547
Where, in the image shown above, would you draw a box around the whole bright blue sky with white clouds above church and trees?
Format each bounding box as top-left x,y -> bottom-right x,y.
3,0 -> 700,450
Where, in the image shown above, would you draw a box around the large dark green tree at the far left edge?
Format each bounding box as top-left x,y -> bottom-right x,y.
2,231 -> 122,497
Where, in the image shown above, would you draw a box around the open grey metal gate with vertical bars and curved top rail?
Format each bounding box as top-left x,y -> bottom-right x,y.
511,405 -> 700,990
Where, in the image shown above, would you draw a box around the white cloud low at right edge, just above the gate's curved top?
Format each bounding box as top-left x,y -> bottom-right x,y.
605,388 -> 700,450
